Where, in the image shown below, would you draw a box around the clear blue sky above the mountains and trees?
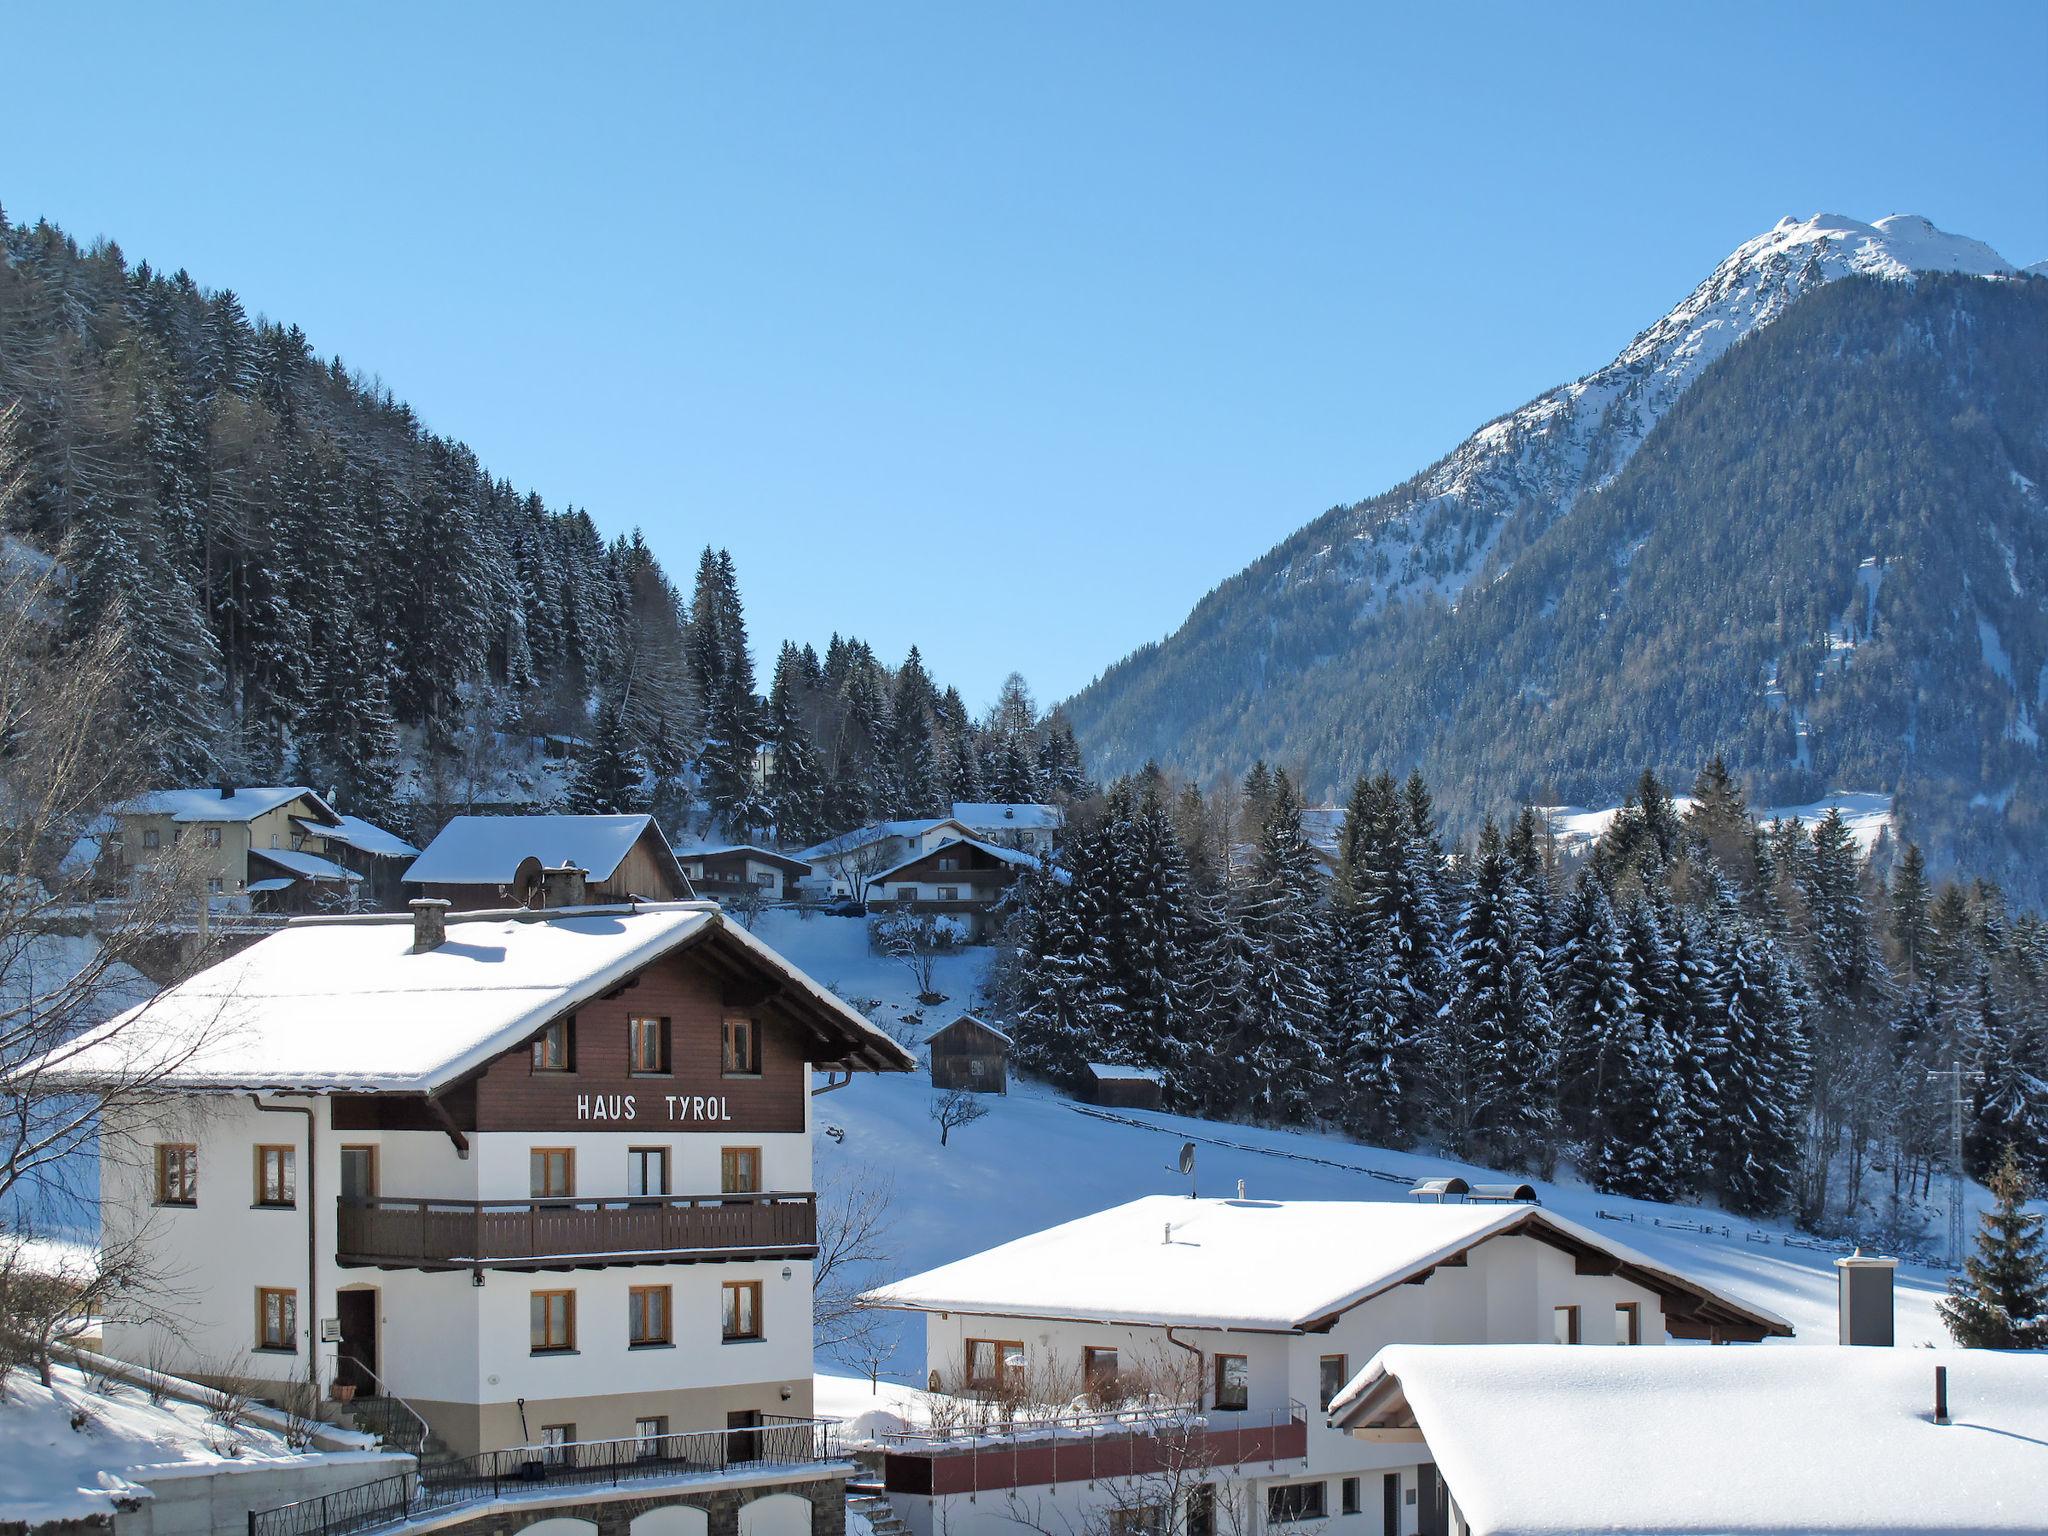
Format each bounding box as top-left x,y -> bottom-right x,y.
0,2 -> 2048,707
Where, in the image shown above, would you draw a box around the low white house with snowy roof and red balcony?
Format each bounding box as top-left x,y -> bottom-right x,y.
870,1196 -> 1790,1536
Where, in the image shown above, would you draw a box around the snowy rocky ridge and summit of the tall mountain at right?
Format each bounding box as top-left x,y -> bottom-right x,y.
1278,213 -> 2013,610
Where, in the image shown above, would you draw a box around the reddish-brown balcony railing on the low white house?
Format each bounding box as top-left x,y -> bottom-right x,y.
883,1403 -> 1309,1495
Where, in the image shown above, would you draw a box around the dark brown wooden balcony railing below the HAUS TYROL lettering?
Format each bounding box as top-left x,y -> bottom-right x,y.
334,1194 -> 817,1270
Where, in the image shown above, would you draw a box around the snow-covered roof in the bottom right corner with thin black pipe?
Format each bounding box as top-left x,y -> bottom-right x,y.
1329,1343 -> 2048,1536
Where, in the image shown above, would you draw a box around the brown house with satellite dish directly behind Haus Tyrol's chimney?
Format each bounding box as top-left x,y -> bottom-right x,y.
406,815 -> 692,911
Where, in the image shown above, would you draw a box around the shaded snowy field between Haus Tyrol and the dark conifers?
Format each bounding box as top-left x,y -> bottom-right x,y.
756,911 -> 1946,1395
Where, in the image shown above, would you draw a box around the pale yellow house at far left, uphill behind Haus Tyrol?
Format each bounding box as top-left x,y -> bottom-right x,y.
106,784 -> 418,911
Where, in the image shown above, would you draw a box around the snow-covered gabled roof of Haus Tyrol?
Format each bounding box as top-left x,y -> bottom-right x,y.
25,901 -> 915,1094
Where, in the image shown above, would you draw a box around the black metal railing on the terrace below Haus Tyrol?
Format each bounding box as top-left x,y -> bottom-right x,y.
248,1415 -> 838,1536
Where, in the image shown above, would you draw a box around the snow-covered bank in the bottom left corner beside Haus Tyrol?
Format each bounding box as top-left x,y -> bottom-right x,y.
0,1366 -> 371,1526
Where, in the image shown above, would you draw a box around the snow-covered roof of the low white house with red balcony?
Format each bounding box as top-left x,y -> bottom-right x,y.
868,1194 -> 1792,1333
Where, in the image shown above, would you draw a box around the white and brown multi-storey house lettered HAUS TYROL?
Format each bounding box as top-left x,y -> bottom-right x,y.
29,901 -> 913,1490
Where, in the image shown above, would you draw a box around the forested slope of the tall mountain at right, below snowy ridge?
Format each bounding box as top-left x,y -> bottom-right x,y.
1067,240 -> 2048,895
